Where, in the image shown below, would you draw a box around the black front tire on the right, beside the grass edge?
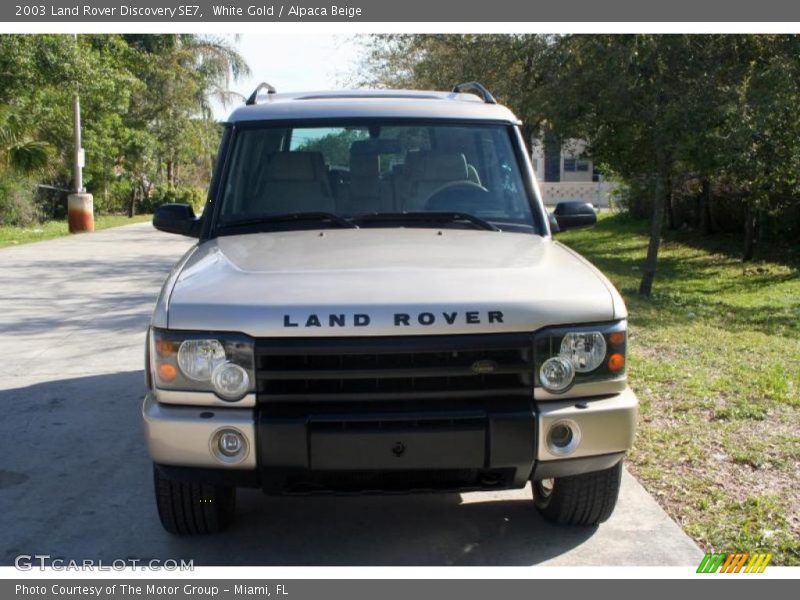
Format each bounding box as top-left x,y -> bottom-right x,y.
531,461 -> 622,525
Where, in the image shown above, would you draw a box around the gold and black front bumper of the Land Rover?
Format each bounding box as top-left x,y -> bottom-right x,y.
142,389 -> 638,490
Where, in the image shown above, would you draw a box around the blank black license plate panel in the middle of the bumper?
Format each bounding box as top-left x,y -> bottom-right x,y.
309,412 -> 486,471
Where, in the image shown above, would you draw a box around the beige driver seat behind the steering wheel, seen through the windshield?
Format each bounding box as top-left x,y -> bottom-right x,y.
402,151 -> 470,212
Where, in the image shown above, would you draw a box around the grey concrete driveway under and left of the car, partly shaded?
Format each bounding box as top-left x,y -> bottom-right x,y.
0,224 -> 702,565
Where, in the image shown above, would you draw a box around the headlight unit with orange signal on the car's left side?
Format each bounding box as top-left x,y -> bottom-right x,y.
150,328 -> 255,402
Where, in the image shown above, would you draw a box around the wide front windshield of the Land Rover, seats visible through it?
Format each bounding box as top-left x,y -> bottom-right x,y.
217,122 -> 534,232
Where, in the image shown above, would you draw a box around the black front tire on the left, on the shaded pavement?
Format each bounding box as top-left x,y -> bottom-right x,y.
153,465 -> 236,535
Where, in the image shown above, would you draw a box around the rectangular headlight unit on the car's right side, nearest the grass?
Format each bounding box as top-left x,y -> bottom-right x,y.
535,321 -> 627,394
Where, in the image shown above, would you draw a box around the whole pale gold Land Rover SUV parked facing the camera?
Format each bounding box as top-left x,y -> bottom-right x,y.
143,83 -> 637,534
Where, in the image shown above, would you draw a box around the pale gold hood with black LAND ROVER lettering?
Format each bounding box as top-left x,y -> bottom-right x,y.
168,228 -> 626,337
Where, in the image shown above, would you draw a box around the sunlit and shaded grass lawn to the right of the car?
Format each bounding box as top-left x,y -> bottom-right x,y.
558,214 -> 800,565
